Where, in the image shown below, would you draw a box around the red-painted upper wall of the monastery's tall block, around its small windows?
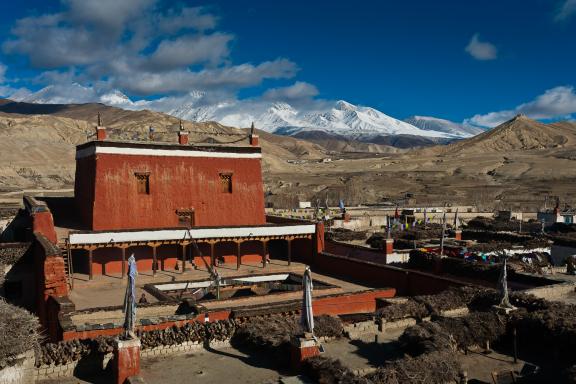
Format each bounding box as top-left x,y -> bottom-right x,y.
75,154 -> 266,230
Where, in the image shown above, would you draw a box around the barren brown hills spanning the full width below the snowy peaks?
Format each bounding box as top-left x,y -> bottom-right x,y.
0,100 -> 576,209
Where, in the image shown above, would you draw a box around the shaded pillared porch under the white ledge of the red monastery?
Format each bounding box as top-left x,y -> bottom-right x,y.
67,234 -> 313,280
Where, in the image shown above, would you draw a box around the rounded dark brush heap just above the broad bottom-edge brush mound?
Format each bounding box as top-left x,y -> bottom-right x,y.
398,322 -> 456,356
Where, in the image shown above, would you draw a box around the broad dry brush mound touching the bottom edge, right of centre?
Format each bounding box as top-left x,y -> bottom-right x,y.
366,351 -> 462,384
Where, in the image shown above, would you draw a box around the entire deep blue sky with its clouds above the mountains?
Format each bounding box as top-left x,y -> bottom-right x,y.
0,0 -> 576,125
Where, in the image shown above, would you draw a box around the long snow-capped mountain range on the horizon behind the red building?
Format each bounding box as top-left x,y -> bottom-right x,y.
11,84 -> 480,142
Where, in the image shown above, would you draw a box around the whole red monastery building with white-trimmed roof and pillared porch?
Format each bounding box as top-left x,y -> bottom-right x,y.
56,126 -> 316,278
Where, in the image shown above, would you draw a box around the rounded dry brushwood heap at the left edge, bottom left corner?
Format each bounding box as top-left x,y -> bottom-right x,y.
0,299 -> 40,369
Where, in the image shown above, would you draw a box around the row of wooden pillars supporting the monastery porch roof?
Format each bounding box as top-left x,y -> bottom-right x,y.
85,239 -> 293,280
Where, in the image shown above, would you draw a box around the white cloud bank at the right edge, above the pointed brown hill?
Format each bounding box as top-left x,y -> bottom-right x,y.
465,86 -> 576,127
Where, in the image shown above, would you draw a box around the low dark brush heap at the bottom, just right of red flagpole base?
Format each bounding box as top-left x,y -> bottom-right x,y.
302,356 -> 370,384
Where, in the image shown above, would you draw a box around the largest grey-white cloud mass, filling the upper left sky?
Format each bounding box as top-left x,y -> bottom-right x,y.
2,0 -> 298,96
